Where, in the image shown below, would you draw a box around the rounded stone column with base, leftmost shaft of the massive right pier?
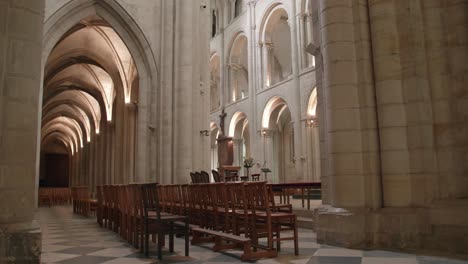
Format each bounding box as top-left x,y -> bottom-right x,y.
317,0 -> 382,246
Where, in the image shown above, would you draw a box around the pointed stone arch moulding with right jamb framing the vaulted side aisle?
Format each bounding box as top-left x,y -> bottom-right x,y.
42,0 -> 159,184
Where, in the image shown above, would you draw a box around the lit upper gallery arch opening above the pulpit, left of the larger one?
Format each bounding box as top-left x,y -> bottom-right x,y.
226,32 -> 249,103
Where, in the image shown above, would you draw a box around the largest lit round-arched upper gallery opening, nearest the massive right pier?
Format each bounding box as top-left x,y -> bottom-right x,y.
259,3 -> 293,87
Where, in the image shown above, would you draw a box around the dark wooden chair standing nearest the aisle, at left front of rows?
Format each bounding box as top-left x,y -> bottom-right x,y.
140,183 -> 190,259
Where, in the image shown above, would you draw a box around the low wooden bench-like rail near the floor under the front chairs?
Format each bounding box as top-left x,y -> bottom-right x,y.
191,227 -> 278,261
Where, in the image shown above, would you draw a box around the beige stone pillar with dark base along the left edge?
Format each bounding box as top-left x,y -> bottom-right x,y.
0,0 -> 44,258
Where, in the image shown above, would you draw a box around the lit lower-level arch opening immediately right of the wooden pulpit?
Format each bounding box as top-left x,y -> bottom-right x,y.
229,112 -> 251,171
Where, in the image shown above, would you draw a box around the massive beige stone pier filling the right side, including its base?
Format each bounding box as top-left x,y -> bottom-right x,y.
317,0 -> 468,253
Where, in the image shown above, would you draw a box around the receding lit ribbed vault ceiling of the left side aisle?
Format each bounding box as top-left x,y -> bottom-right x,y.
41,17 -> 138,155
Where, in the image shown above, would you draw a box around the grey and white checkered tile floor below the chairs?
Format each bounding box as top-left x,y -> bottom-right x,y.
37,207 -> 468,264
